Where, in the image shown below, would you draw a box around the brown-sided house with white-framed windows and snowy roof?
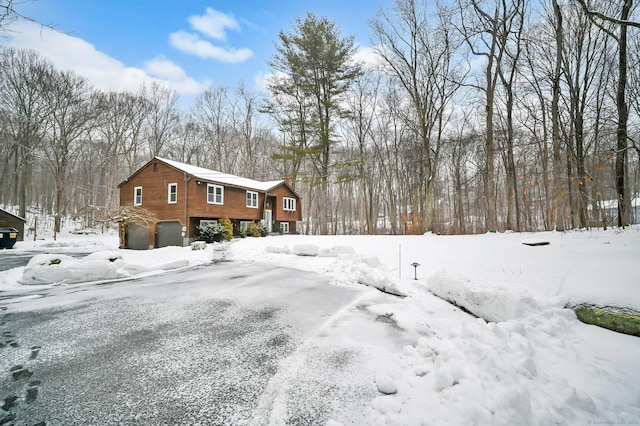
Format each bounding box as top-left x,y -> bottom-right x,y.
118,157 -> 302,249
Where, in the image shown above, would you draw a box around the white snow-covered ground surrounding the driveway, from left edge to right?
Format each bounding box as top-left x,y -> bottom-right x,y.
0,227 -> 640,425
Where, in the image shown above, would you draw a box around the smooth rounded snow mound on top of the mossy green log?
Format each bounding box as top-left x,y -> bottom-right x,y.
558,260 -> 640,311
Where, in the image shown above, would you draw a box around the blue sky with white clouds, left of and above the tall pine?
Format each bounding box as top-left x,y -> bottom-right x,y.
0,0 -> 392,98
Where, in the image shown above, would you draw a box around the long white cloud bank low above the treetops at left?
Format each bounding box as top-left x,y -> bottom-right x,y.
7,22 -> 209,95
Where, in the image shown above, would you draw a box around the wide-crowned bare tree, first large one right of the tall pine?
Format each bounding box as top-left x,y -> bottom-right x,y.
371,0 -> 459,230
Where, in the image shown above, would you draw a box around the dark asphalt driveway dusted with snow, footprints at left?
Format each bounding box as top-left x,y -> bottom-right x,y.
0,262 -> 366,425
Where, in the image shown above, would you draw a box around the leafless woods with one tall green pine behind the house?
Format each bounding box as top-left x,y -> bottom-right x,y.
0,0 -> 640,234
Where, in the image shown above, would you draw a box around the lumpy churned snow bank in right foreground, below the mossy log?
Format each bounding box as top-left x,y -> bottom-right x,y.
368,300 -> 640,425
